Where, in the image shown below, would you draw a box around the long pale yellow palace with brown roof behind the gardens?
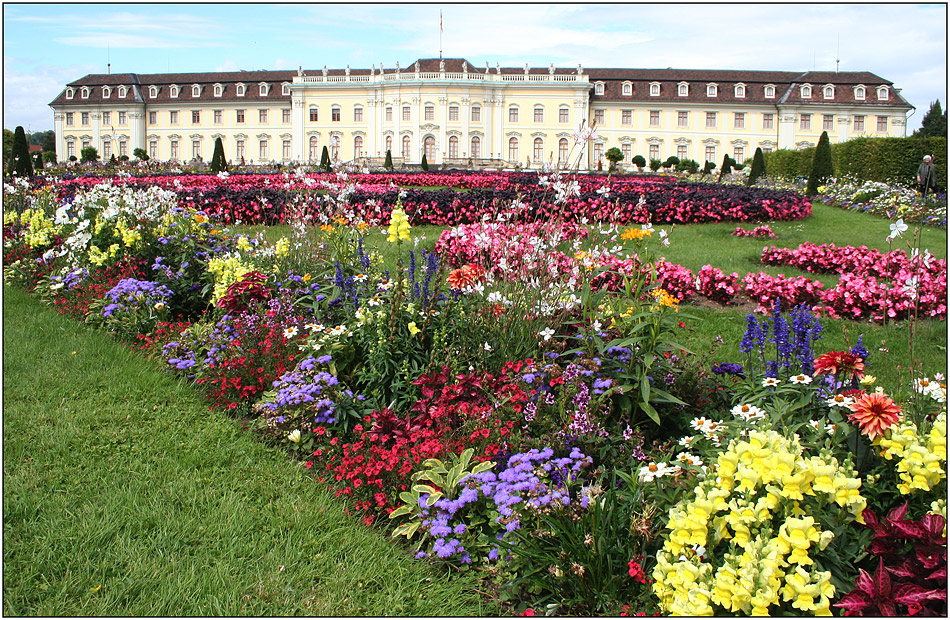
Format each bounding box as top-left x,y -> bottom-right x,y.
50,58 -> 913,169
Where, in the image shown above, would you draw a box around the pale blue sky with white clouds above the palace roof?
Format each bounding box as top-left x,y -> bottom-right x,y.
3,3 -> 947,132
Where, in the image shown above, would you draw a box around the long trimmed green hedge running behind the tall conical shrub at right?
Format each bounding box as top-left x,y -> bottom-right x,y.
765,138 -> 947,187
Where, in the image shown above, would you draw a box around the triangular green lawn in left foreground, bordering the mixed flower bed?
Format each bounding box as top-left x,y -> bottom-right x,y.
3,287 -> 497,616
